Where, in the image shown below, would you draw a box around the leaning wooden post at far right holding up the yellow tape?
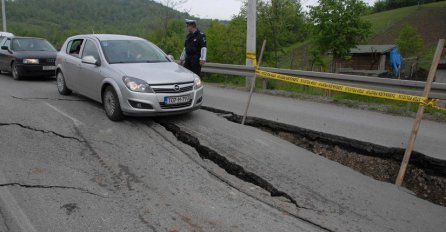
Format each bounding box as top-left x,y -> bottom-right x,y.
395,39 -> 445,186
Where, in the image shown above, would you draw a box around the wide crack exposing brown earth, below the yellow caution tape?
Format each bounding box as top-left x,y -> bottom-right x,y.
202,107 -> 446,206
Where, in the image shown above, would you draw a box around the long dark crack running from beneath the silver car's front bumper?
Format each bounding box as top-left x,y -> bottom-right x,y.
155,119 -> 333,232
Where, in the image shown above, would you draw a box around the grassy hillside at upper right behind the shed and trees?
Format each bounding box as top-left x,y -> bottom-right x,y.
280,1 -> 446,69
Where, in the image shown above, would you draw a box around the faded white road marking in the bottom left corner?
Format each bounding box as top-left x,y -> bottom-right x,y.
0,171 -> 37,232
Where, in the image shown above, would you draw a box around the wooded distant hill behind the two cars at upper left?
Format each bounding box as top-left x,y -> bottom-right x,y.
7,0 -> 204,46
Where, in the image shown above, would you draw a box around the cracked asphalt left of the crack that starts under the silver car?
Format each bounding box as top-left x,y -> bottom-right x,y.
0,76 -> 325,232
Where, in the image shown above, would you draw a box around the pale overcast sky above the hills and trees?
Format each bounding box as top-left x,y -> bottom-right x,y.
156,0 -> 376,20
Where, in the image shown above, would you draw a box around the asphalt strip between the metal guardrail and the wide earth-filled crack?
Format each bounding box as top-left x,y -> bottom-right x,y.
204,85 -> 446,160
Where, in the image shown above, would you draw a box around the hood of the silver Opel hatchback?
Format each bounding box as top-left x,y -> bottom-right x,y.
111,62 -> 196,85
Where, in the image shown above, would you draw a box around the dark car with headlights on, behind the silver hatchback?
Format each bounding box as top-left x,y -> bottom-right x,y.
0,36 -> 57,80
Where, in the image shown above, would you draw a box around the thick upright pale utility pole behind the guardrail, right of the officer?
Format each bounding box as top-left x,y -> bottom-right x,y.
246,0 -> 257,88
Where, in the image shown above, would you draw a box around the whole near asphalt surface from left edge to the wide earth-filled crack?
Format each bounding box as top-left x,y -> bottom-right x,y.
0,75 -> 446,232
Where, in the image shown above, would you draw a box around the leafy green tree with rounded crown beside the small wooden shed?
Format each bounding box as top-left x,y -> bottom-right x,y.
309,0 -> 371,71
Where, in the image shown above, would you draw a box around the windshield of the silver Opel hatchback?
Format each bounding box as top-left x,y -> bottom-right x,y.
101,40 -> 169,64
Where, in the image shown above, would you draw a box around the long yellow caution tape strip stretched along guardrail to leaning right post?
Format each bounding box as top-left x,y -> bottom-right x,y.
256,69 -> 446,110
